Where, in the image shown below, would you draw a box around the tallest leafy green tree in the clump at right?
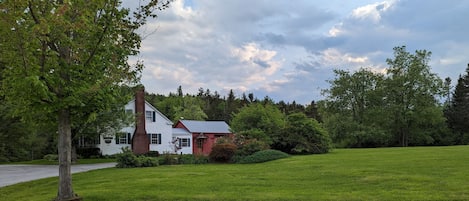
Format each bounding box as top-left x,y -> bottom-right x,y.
385,46 -> 446,146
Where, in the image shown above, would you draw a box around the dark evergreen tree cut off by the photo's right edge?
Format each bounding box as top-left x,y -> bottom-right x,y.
445,64 -> 469,144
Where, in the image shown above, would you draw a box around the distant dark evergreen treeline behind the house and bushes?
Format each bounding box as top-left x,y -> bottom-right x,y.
145,86 -> 321,123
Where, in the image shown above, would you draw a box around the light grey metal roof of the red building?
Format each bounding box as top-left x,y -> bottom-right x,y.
179,120 -> 231,134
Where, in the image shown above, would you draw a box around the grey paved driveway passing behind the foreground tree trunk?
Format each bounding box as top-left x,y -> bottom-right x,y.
0,163 -> 116,188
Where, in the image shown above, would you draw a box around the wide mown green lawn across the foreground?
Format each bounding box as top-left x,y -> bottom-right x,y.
0,146 -> 469,201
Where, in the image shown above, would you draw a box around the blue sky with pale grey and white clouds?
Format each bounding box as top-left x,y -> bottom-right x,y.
128,0 -> 469,104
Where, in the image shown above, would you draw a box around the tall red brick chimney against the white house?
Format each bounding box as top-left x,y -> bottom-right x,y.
132,86 -> 150,154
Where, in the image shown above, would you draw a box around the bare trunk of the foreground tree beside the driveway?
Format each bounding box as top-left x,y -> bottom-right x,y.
56,109 -> 79,201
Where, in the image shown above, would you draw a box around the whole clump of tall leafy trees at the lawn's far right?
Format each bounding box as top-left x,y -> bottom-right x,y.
322,46 -> 447,147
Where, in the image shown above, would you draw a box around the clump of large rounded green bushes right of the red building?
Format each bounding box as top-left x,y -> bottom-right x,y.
231,103 -> 331,154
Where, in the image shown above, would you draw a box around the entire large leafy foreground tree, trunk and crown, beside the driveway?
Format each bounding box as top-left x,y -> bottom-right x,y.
0,0 -> 169,200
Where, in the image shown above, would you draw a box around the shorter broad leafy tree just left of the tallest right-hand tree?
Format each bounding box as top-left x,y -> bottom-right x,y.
322,68 -> 390,147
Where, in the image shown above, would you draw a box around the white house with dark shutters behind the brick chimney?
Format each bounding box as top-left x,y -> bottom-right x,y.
97,99 -> 192,155
